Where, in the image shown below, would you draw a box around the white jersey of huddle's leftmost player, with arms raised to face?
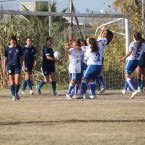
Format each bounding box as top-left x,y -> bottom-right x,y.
69,48 -> 83,73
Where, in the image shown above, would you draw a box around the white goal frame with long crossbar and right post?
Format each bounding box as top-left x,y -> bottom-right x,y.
0,10 -> 130,52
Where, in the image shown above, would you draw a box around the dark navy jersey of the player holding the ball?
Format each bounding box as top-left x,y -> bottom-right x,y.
42,46 -> 55,68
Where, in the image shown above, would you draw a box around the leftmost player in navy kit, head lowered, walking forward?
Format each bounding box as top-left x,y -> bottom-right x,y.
4,36 -> 22,101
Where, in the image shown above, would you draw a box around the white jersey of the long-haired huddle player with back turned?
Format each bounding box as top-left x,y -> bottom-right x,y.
86,48 -> 102,65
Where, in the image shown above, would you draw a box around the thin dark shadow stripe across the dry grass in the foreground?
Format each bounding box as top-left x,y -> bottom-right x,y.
0,119 -> 145,126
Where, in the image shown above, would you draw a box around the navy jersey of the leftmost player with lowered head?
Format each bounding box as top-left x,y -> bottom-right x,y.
4,45 -> 22,66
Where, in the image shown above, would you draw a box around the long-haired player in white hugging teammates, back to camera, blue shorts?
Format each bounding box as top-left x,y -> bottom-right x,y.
80,38 -> 102,99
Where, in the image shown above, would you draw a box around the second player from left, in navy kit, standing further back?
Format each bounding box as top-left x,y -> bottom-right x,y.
22,37 -> 37,95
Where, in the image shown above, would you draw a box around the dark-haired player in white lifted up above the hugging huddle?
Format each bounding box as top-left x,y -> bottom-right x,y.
97,29 -> 113,94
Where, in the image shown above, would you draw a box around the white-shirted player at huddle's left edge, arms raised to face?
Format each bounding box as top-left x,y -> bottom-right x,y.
65,41 -> 83,99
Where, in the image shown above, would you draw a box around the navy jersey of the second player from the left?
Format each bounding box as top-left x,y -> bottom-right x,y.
22,46 -> 37,66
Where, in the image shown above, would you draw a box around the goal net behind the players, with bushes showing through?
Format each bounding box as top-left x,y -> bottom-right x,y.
0,1 -> 128,89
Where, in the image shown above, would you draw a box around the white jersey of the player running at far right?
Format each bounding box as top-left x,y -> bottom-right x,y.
127,41 -> 145,60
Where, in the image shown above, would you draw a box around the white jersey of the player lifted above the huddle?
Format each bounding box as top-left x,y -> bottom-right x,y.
97,38 -> 108,58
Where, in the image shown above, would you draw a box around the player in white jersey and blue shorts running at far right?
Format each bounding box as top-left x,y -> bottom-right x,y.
119,32 -> 145,99
